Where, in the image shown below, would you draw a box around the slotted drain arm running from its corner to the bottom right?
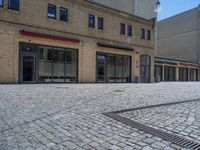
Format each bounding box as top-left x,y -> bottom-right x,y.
103,112 -> 200,150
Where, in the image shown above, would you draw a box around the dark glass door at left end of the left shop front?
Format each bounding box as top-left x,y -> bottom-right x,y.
23,56 -> 35,82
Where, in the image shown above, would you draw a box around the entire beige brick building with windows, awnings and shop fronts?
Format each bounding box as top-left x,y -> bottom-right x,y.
0,0 -> 154,83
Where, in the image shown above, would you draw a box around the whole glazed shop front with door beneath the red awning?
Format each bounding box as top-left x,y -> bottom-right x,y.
19,43 -> 78,83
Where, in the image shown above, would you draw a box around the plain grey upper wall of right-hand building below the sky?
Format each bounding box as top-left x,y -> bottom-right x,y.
158,9 -> 200,62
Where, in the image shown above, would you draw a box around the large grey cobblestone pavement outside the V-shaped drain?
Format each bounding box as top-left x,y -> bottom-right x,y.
0,83 -> 200,150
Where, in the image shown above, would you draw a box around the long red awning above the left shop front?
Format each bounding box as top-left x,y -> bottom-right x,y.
20,30 -> 80,43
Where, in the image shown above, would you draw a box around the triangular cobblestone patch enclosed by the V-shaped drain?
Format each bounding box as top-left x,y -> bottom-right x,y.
121,100 -> 200,143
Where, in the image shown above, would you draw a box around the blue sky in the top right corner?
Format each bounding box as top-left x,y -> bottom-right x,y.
158,0 -> 200,20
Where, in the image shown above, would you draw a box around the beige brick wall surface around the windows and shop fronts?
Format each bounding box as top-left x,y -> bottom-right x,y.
0,0 -> 154,83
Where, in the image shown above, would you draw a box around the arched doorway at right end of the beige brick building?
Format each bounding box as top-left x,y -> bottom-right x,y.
140,55 -> 151,83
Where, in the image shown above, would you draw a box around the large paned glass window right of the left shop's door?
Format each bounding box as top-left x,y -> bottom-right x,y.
39,46 -> 77,82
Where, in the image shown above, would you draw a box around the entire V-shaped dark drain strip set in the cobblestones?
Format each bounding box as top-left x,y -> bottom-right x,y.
103,99 -> 200,150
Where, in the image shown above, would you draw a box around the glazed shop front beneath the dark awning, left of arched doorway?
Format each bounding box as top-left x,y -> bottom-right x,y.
96,53 -> 131,83
